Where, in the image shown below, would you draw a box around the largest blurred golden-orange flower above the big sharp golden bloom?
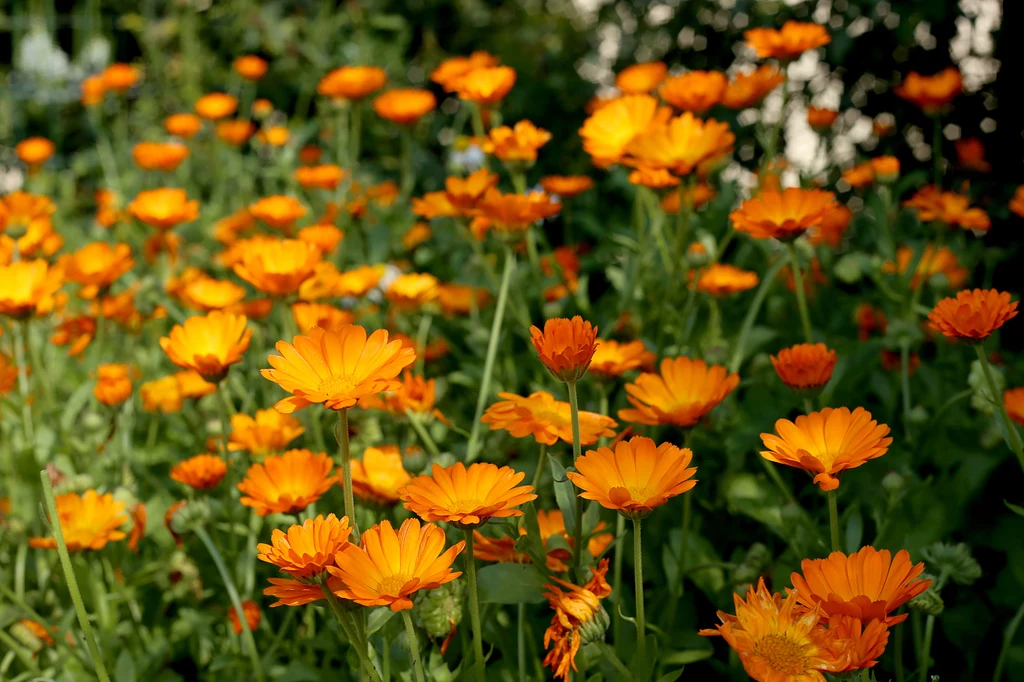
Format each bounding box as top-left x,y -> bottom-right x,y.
233,240 -> 323,296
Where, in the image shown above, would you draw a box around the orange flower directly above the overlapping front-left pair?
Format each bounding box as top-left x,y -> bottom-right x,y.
239,450 -> 338,516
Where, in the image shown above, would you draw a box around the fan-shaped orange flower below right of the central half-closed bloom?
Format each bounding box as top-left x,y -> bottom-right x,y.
565,436 -> 697,519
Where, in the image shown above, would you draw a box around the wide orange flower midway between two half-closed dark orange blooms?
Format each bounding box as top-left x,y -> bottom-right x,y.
618,357 -> 739,428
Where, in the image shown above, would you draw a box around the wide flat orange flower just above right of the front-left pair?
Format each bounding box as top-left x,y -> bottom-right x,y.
398,462 -> 537,530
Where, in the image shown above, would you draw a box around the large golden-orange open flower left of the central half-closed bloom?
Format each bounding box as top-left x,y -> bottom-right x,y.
260,325 -> 416,414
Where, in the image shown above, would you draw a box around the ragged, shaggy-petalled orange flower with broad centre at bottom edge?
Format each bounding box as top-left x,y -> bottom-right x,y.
700,578 -> 846,682
